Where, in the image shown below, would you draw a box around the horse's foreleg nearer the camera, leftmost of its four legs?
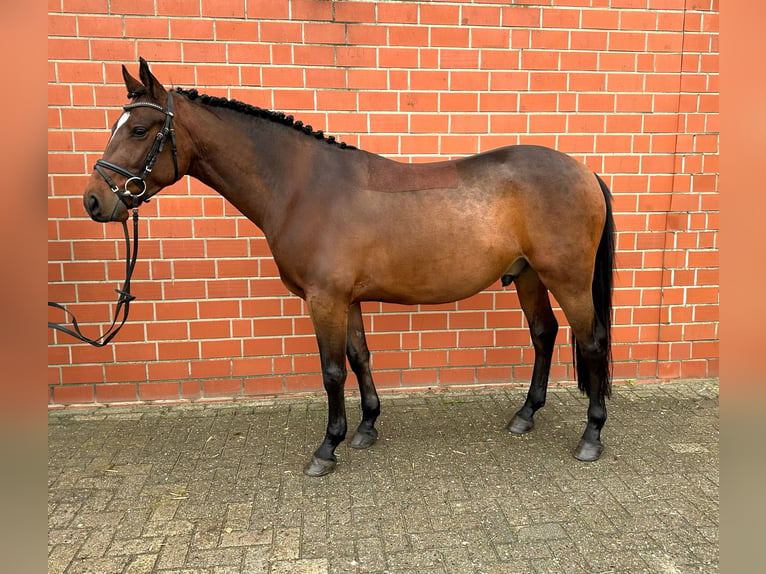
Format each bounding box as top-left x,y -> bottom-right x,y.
303,296 -> 348,476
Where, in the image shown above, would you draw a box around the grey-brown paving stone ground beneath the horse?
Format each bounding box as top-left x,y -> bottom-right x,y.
48,380 -> 719,574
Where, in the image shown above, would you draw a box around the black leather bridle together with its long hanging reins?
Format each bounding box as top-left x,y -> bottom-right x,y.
48,91 -> 178,347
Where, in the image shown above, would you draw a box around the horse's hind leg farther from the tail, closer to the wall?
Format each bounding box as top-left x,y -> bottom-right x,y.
507,267 -> 559,434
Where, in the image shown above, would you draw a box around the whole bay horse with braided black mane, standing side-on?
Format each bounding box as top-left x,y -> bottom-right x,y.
83,58 -> 615,476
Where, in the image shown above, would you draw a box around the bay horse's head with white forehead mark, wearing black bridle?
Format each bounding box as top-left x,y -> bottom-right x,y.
83,58 -> 188,222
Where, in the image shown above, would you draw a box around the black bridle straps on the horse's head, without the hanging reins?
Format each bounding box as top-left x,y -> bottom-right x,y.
95,91 -> 178,208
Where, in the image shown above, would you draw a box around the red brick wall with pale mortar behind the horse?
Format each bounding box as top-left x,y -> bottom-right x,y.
48,0 -> 718,405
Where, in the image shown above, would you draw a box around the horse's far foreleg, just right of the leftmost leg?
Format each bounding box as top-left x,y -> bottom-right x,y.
346,303 -> 380,448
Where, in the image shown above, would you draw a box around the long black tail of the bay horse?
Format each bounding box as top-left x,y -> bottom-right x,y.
572,175 -> 615,397
